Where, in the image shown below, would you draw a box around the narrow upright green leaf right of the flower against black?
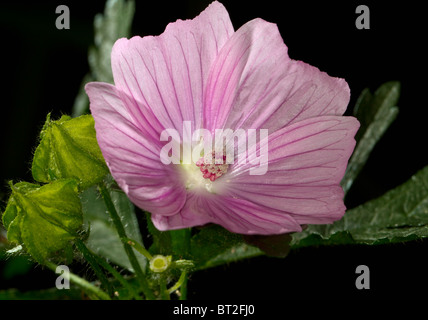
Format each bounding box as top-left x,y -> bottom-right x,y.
341,81 -> 400,194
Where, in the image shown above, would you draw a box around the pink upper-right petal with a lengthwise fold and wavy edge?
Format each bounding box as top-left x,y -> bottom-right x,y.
205,19 -> 350,133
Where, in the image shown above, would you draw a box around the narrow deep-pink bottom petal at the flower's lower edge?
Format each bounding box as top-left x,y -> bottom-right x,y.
152,193 -> 302,234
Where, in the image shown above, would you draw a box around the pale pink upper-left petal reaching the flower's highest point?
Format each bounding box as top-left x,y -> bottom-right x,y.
111,2 -> 233,136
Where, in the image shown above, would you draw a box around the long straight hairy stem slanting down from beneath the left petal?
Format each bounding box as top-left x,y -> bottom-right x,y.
99,183 -> 155,300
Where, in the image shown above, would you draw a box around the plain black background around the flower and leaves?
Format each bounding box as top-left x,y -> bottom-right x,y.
0,0 -> 428,299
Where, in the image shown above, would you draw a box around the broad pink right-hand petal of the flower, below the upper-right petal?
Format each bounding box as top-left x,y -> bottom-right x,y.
221,116 -> 359,224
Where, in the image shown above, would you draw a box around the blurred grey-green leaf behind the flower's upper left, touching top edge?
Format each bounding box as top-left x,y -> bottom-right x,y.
89,0 -> 135,83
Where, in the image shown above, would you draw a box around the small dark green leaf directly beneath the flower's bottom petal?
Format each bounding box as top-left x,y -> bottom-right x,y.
190,225 -> 263,270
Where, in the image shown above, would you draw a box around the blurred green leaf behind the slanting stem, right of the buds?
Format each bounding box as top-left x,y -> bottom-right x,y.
80,187 -> 147,270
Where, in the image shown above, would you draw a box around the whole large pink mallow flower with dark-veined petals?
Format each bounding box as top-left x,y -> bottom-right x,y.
86,2 -> 359,234
